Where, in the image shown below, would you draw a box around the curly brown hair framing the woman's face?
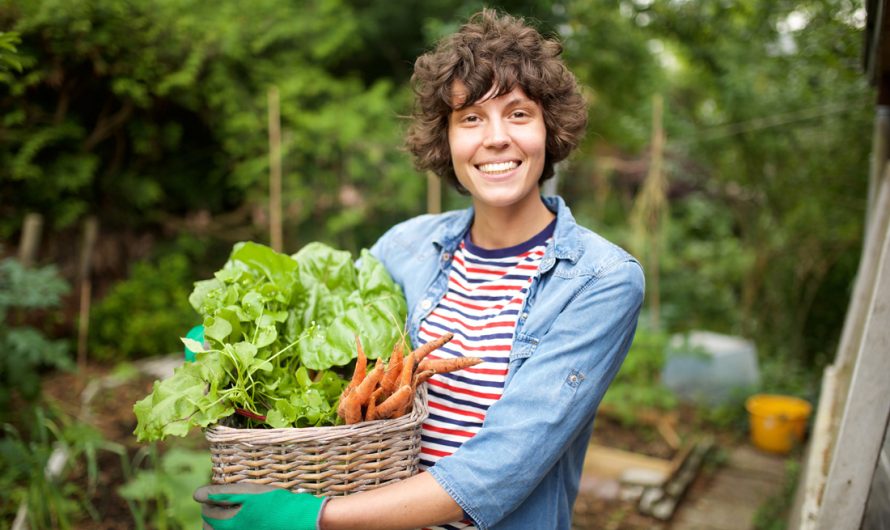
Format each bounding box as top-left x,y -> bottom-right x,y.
406,9 -> 587,193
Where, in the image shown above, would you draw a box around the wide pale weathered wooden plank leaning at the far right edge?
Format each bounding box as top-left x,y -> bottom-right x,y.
816,208 -> 890,530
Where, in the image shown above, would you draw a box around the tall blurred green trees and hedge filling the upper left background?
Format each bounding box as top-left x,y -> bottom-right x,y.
0,0 -> 424,249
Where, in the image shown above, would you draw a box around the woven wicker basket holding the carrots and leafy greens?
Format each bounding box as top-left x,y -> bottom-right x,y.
205,385 -> 428,496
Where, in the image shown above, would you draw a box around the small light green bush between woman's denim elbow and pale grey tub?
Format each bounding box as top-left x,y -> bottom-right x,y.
602,319 -> 677,425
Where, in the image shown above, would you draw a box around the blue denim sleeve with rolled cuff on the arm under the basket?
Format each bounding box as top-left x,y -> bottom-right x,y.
429,259 -> 644,529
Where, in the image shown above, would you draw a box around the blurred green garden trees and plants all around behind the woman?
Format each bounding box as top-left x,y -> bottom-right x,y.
0,0 -> 874,528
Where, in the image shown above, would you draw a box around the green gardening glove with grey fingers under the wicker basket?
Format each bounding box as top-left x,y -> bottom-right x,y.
195,484 -> 326,530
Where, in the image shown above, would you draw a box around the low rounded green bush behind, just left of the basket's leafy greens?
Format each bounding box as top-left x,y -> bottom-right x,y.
90,254 -> 200,361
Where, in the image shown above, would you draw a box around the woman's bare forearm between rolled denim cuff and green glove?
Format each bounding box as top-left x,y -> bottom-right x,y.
319,472 -> 463,530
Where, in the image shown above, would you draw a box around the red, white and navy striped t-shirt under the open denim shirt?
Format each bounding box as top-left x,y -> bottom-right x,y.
420,220 -> 556,528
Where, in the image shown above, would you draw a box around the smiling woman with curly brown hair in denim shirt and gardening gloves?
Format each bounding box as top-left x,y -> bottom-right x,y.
199,10 -> 643,530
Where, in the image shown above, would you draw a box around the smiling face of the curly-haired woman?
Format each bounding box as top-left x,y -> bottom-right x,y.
448,81 -> 547,209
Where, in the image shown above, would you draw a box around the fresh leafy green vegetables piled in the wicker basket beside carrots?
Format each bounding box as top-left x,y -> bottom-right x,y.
133,243 -> 407,441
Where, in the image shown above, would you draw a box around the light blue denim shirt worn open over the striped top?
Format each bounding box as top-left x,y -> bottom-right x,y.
371,197 -> 644,530
